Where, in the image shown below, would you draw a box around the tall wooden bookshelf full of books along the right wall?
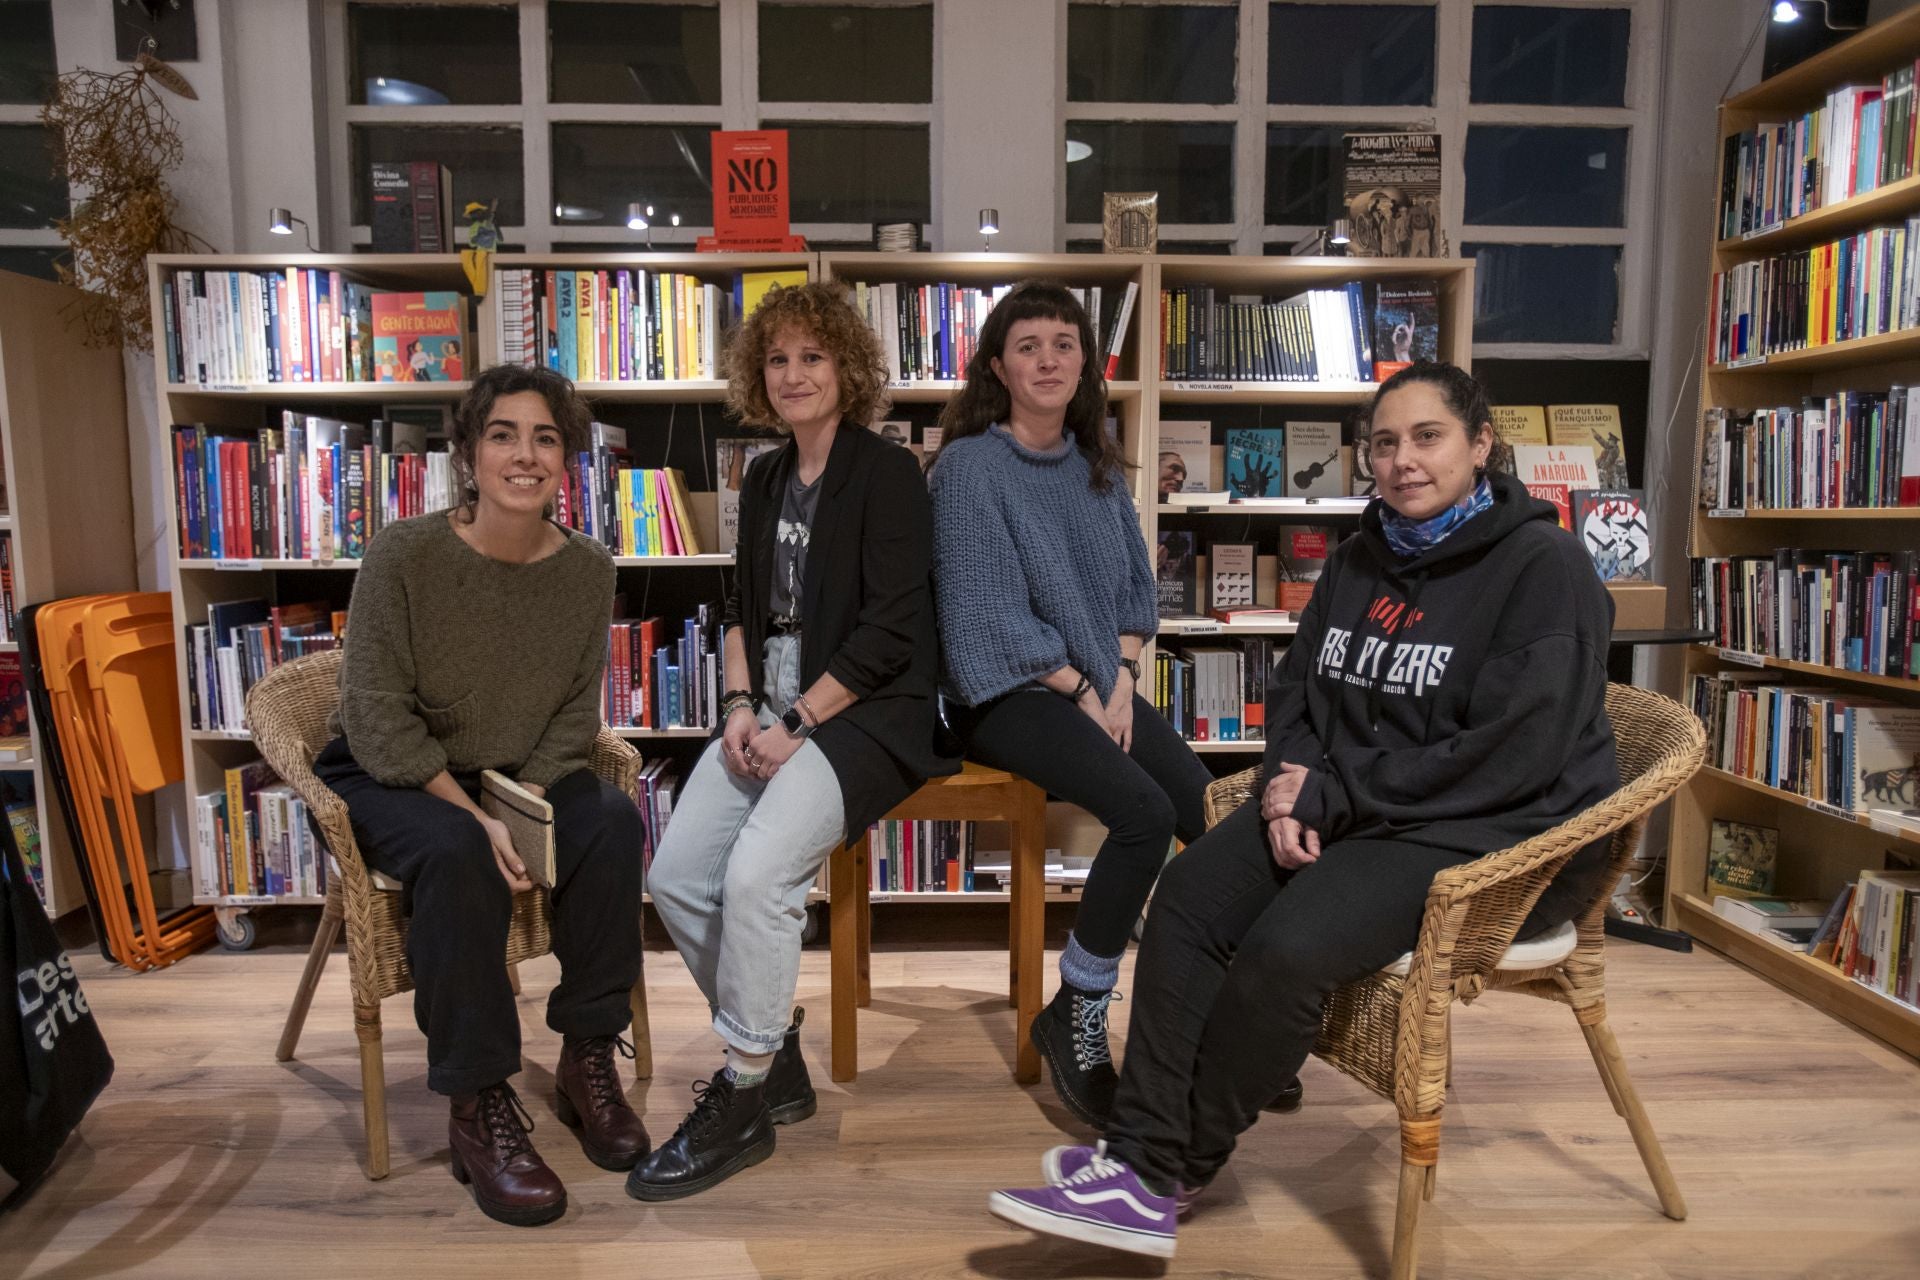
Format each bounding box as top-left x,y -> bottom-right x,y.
1667,0 -> 1920,1055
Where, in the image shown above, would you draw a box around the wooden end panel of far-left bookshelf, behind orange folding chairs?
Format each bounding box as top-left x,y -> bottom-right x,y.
0,271 -> 136,915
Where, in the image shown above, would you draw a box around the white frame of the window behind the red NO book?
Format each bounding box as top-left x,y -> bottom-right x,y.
324,0 -> 950,253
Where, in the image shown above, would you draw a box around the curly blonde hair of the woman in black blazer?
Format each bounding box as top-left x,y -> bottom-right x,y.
726,280 -> 893,432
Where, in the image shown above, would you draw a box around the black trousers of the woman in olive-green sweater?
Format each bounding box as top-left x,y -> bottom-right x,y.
313,739 -> 641,1096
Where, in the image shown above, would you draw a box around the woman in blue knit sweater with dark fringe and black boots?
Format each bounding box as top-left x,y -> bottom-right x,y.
933,282 -> 1210,1126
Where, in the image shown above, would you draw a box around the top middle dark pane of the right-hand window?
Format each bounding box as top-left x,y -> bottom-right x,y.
1267,4 -> 1434,107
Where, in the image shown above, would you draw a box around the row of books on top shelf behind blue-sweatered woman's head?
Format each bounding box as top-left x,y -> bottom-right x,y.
852,280 -> 1139,382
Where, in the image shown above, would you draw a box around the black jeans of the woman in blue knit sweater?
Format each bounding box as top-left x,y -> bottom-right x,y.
947,689 -> 1213,956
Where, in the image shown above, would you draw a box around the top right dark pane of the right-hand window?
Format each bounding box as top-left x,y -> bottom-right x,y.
1473,4 -> 1634,107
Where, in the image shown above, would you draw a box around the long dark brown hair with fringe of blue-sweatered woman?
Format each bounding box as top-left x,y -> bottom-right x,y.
935,280 -> 1131,491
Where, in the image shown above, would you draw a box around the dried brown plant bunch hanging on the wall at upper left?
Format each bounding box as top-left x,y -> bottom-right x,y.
40,54 -> 211,351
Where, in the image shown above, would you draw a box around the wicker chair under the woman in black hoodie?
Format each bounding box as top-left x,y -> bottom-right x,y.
1206,685 -> 1705,1280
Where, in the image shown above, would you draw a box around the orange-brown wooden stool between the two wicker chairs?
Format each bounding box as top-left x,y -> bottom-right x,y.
828,762 -> 1046,1084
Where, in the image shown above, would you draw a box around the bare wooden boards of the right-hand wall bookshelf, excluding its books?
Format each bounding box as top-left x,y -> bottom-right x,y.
1667,10 -> 1920,1055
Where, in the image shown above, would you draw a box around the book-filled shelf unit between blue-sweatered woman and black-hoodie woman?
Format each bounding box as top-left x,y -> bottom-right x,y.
1142,257 -> 1473,771
